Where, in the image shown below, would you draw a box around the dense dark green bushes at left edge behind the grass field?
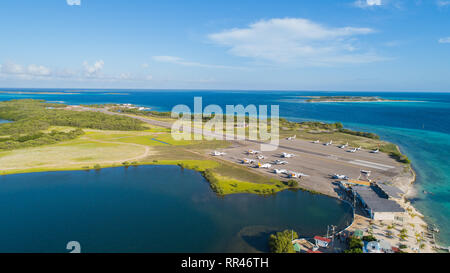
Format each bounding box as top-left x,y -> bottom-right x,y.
0,99 -> 146,150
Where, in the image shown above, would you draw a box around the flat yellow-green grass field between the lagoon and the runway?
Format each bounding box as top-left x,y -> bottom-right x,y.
0,126 -> 286,195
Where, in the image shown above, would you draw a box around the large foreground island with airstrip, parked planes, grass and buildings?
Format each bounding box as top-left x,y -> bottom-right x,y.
0,99 -> 434,253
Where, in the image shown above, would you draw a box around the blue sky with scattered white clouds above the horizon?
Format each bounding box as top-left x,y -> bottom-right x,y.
0,0 -> 450,91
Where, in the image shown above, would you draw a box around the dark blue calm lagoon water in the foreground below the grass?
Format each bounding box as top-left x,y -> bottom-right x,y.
0,166 -> 353,252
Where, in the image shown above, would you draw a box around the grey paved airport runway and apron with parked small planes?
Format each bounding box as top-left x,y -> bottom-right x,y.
74,107 -> 403,196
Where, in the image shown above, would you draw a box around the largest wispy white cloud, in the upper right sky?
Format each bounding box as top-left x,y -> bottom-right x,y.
208,18 -> 383,65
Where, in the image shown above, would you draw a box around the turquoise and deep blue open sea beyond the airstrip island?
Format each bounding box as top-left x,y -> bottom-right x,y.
0,89 -> 450,245
